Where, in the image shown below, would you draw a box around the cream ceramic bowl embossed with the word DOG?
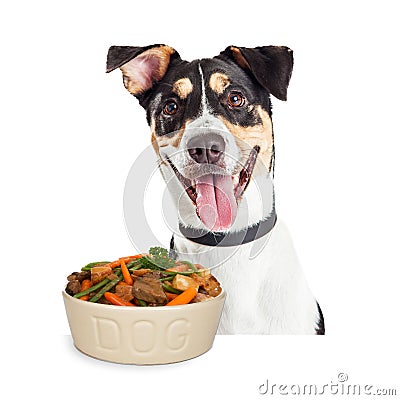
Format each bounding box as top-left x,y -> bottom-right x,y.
62,291 -> 225,365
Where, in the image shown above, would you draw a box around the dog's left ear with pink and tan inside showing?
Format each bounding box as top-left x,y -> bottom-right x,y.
106,44 -> 180,96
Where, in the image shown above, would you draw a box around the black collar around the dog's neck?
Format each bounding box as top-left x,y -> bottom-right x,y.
179,207 -> 276,247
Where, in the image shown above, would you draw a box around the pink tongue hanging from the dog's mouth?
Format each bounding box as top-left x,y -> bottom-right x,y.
195,174 -> 237,231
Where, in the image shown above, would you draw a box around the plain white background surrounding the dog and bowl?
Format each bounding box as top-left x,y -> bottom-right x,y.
0,0 -> 400,399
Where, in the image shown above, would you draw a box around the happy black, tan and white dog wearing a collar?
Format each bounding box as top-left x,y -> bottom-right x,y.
106,44 -> 325,335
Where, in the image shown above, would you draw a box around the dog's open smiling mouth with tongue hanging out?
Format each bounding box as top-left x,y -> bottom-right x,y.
167,146 -> 260,231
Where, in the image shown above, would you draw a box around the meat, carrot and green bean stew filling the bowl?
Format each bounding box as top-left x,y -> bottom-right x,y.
65,247 -> 222,307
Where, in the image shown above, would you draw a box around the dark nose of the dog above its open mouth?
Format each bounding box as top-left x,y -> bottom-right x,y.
187,134 -> 225,164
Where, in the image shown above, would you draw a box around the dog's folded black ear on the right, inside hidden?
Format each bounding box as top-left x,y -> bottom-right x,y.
221,46 -> 293,100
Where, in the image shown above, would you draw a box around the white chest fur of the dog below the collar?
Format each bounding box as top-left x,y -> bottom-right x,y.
175,219 -> 319,334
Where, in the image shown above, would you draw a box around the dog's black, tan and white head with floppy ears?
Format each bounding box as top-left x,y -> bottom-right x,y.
107,45 -> 293,231
